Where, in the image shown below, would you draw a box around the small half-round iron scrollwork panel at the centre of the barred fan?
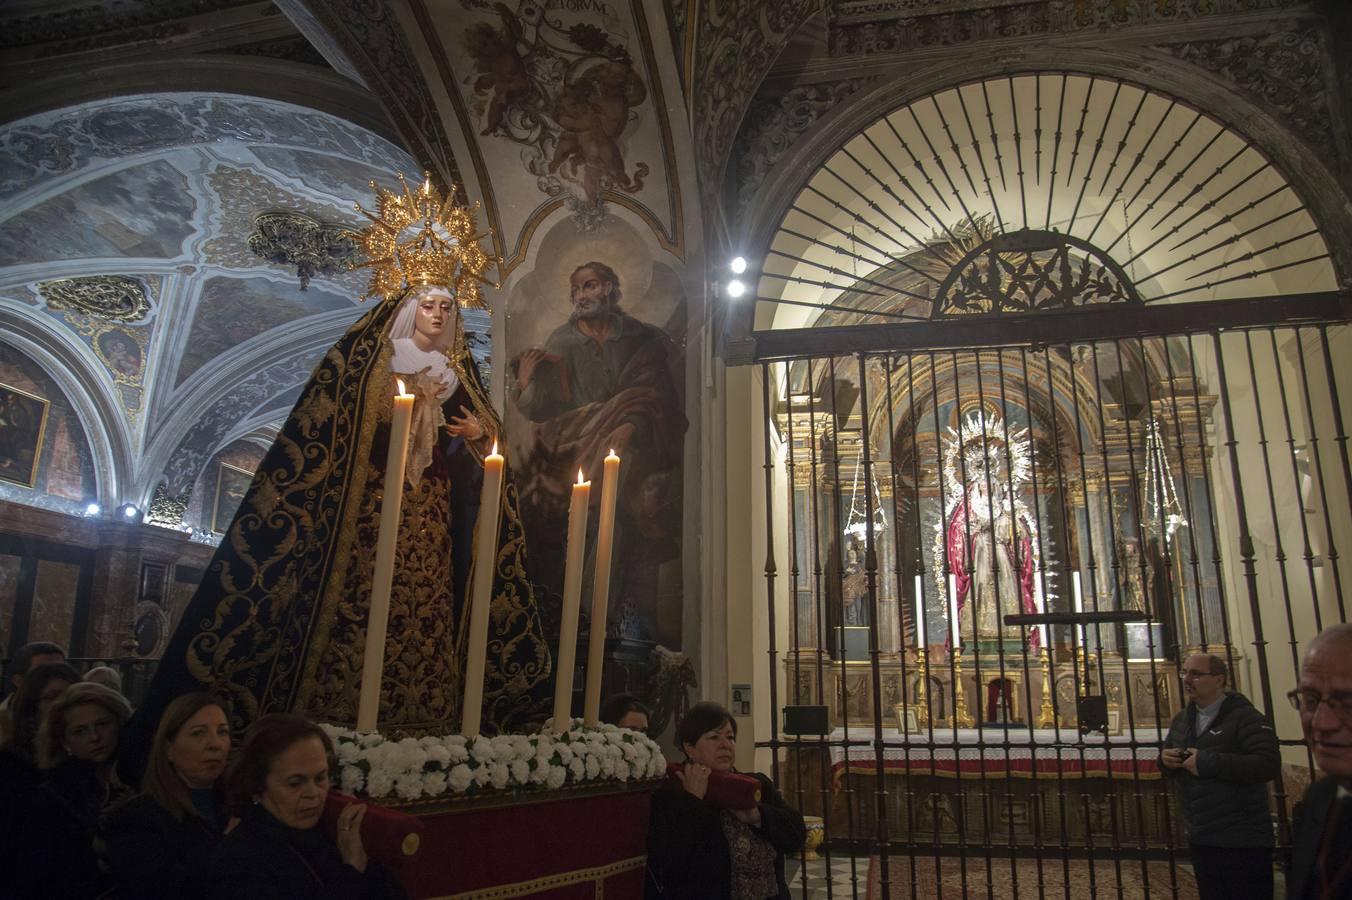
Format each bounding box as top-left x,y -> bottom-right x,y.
932,231 -> 1141,319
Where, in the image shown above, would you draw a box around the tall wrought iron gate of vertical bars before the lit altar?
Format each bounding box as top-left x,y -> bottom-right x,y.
756,290 -> 1352,897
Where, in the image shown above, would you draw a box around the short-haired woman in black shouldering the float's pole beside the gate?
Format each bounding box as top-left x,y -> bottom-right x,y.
646,701 -> 806,900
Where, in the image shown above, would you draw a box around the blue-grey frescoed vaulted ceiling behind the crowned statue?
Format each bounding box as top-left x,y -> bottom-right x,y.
0,93 -> 459,518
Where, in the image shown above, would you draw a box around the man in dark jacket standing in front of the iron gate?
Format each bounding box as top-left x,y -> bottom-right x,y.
1160,653 -> 1282,900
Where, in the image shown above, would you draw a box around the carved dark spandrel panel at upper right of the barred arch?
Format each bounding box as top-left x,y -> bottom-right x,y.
1160,26 -> 1337,159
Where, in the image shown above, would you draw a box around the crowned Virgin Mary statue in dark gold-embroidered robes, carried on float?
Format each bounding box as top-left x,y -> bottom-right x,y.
128,177 -> 550,778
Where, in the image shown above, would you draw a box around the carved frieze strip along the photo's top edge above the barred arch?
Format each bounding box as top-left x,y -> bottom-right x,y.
827,0 -> 1307,57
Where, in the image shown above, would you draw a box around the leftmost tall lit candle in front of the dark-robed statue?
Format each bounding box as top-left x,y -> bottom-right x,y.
357,378 -> 414,731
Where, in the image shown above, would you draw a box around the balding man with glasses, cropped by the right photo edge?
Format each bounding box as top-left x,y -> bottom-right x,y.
1286,624 -> 1352,900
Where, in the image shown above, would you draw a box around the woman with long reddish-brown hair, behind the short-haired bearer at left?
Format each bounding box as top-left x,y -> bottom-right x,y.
101,693 -> 230,900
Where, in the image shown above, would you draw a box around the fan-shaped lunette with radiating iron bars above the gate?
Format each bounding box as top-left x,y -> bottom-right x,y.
757,74 -> 1336,328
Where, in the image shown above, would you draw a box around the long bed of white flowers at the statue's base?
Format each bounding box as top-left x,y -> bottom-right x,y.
322,719 -> 667,801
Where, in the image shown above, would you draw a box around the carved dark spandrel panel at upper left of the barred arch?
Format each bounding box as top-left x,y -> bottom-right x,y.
733,78 -> 876,215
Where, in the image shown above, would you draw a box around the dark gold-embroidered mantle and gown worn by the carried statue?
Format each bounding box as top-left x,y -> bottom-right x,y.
130,289 -> 552,759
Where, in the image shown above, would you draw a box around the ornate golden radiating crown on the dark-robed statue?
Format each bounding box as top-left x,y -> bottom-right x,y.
353,172 -> 491,309
